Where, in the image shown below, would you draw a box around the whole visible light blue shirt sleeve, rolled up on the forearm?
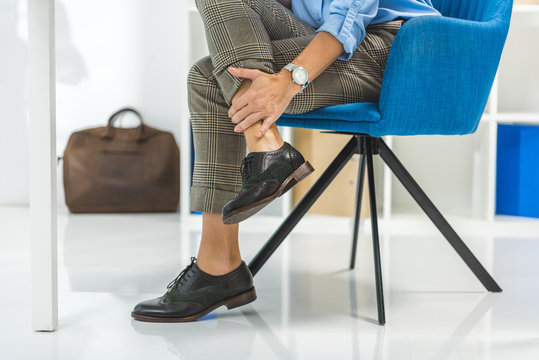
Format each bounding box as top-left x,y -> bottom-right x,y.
316,0 -> 379,61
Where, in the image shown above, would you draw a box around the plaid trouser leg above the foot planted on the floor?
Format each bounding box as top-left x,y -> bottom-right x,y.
188,57 -> 245,214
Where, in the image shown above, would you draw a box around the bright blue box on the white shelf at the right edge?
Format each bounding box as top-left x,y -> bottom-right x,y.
496,125 -> 539,218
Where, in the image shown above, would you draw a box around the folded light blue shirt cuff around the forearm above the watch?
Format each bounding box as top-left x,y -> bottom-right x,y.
316,12 -> 365,61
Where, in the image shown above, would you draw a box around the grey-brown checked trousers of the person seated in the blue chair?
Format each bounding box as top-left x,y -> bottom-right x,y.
188,0 -> 404,213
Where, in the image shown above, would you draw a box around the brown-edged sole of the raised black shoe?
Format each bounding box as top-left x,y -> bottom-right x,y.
223,161 -> 314,225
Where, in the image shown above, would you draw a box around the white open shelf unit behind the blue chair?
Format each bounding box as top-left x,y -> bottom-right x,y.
181,0 -> 539,220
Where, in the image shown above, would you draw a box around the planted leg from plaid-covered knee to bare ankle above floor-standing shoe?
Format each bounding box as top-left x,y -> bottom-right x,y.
188,57 -> 245,275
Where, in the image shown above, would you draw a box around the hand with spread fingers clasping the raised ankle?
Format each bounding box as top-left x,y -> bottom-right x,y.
228,67 -> 301,137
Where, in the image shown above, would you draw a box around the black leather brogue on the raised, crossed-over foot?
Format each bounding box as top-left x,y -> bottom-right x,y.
223,142 -> 314,224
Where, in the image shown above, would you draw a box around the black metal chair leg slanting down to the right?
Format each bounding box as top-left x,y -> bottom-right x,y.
378,139 -> 502,292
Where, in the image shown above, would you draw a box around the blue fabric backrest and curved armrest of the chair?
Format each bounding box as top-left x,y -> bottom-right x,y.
373,0 -> 513,135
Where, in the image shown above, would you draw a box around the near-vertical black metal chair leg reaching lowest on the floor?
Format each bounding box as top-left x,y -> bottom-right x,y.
364,138 -> 386,325
